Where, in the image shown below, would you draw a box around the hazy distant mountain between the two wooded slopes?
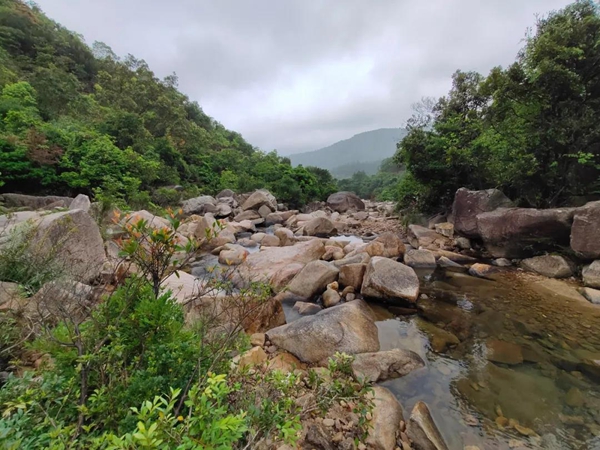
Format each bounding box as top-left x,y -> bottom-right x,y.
289,128 -> 406,178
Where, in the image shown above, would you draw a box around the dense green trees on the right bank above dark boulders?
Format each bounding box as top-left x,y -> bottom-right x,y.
395,0 -> 600,210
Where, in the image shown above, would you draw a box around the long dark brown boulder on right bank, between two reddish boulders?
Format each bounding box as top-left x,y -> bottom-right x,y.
477,208 -> 575,258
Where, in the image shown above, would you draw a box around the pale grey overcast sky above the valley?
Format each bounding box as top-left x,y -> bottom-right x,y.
37,0 -> 569,154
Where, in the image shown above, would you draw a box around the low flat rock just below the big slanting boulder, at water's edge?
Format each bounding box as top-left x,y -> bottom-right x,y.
352,348 -> 425,383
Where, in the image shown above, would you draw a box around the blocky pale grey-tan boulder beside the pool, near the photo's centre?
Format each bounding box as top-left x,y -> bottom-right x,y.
361,256 -> 419,302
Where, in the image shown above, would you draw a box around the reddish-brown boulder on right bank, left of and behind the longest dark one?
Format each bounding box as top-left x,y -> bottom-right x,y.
452,188 -> 513,238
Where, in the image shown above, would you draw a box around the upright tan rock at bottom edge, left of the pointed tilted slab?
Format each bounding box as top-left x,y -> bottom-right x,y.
365,386 -> 403,450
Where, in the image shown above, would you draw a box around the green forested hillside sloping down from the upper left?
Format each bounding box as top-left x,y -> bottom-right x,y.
0,0 -> 334,206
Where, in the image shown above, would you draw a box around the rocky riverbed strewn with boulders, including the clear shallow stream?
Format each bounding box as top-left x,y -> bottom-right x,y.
0,190 -> 600,450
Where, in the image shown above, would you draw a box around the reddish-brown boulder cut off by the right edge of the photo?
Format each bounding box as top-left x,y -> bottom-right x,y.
571,201 -> 600,259
